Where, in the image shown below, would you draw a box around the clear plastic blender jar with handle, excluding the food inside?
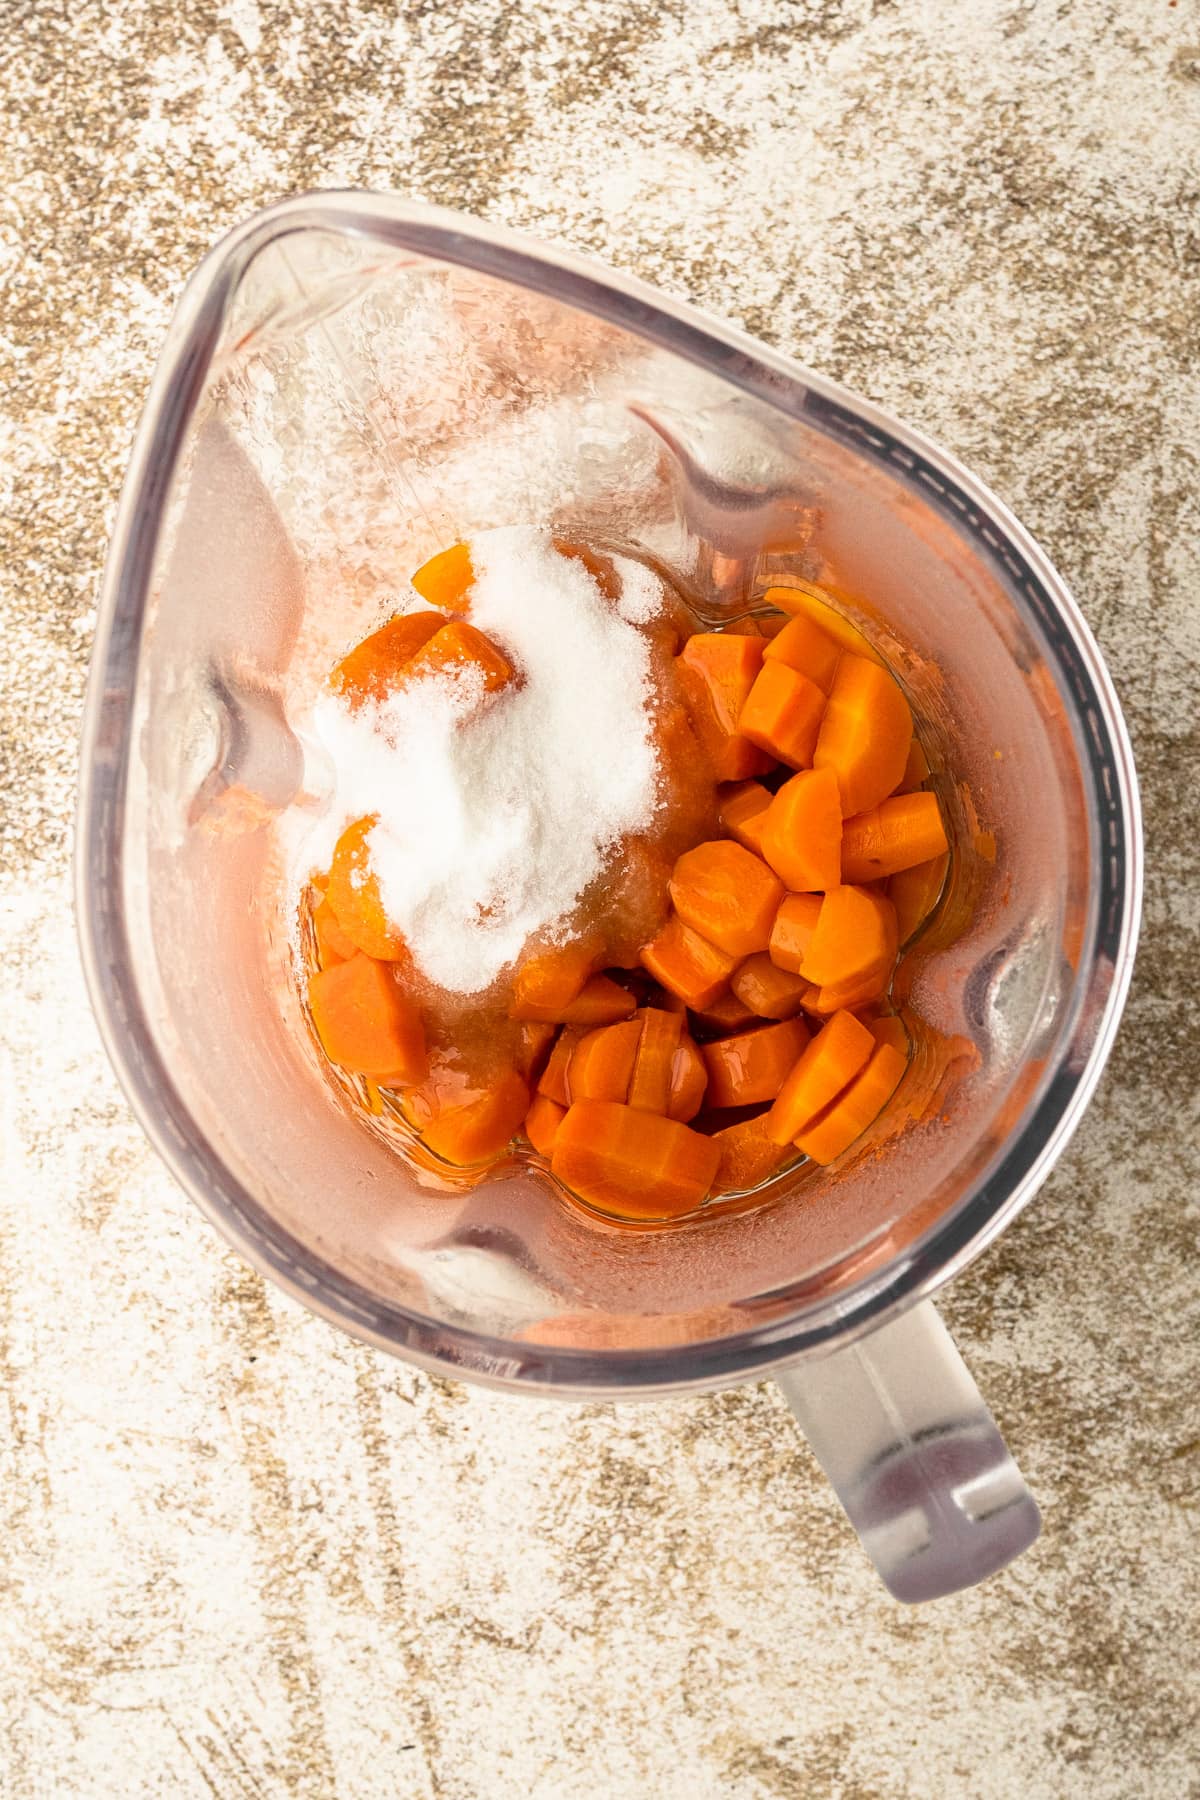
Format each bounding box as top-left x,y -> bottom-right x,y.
77,194 -> 1141,1600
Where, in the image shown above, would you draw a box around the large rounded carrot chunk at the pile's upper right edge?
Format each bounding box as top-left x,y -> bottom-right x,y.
813,657 -> 912,815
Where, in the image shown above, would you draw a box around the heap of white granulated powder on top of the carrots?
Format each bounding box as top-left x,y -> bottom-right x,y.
296,526 -> 662,994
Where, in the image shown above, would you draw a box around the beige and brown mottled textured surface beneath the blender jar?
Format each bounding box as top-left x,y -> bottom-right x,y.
0,0 -> 1200,1800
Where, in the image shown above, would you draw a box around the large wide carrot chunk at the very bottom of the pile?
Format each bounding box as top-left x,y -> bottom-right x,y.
551,1100 -> 720,1219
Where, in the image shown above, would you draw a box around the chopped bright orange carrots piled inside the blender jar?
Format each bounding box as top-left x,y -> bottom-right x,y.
308,545 -> 950,1220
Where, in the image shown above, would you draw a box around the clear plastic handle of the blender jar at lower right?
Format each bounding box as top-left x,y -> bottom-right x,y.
775,1300 -> 1042,1602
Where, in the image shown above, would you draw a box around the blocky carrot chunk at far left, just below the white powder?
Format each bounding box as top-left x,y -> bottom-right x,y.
308,952 -> 428,1082
